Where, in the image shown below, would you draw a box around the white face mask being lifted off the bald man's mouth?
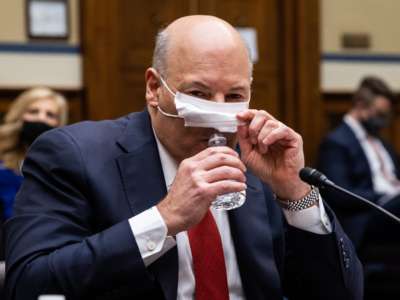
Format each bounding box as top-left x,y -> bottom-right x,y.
157,77 -> 250,132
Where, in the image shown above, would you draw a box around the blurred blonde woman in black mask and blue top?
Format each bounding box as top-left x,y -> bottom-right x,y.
0,87 -> 68,219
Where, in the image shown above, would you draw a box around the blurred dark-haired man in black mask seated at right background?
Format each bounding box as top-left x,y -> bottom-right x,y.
318,77 -> 400,247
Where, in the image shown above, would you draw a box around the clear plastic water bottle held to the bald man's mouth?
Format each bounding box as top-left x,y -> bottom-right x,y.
208,133 -> 246,210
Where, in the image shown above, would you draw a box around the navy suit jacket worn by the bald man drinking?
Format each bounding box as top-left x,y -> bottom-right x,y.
6,112 -> 362,300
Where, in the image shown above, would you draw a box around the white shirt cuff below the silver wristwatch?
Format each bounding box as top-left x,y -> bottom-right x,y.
283,195 -> 332,234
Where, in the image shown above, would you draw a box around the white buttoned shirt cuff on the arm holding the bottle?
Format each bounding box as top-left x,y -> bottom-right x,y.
129,206 -> 176,267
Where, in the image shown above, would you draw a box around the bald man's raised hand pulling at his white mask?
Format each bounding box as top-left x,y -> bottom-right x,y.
238,109 -> 310,200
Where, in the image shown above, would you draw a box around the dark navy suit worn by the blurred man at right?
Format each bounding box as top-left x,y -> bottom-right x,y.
318,122 -> 400,246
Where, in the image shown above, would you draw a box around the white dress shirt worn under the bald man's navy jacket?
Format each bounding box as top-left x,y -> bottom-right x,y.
129,133 -> 332,300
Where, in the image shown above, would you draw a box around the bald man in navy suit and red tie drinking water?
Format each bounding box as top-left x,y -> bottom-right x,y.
7,16 -> 362,300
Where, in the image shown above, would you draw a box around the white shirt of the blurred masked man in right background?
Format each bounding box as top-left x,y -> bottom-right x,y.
344,115 -> 400,200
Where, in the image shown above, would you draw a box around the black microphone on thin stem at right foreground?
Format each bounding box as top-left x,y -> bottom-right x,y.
299,167 -> 400,223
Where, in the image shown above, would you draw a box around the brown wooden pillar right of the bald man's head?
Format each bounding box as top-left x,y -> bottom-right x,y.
277,0 -> 323,164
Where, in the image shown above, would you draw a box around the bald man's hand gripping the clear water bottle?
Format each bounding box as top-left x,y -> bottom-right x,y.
157,147 -> 246,235
